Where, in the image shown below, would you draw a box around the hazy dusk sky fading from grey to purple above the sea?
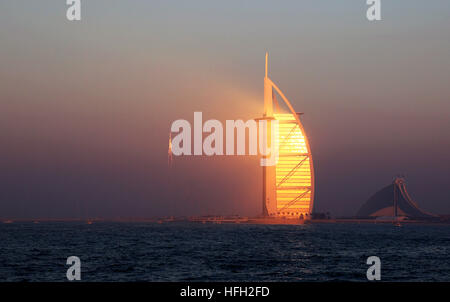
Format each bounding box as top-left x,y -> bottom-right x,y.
0,0 -> 450,219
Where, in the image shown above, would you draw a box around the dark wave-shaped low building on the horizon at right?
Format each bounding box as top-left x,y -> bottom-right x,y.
356,177 -> 436,218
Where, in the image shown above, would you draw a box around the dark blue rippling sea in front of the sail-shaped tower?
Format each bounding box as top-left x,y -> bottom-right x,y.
0,222 -> 450,282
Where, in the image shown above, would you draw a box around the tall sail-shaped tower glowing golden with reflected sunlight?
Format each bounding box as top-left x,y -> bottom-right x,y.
262,54 -> 314,219
